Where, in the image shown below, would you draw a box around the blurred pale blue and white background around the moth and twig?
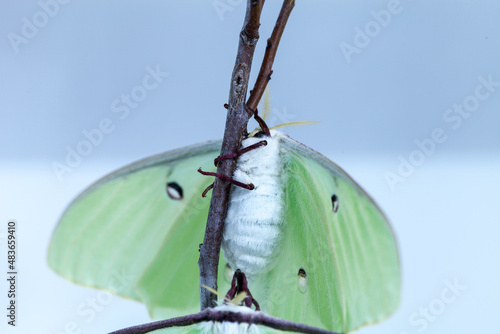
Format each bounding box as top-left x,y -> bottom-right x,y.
0,0 -> 500,334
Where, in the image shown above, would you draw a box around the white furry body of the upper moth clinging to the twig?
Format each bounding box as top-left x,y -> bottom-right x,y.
222,132 -> 283,279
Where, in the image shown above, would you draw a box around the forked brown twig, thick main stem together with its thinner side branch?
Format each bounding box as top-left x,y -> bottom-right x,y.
198,0 -> 295,310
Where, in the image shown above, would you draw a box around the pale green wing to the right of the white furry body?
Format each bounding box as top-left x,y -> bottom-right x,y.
254,137 -> 400,333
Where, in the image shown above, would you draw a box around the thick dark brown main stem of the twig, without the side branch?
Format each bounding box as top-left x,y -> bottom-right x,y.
198,0 -> 264,310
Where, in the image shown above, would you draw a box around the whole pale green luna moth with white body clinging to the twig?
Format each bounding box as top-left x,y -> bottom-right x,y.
48,126 -> 400,333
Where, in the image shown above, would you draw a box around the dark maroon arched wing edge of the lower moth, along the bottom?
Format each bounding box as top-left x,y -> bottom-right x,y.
110,308 -> 338,334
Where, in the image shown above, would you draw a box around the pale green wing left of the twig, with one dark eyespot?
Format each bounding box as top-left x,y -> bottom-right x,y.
48,141 -> 223,316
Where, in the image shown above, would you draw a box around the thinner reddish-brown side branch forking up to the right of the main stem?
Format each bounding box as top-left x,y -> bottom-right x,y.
247,0 -> 295,111
